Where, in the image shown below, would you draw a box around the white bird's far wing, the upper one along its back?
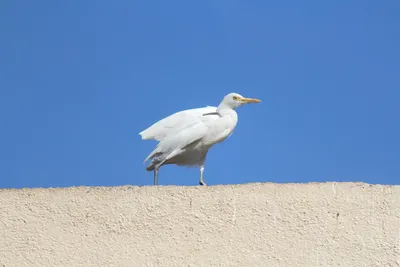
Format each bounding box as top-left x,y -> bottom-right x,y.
139,106 -> 217,141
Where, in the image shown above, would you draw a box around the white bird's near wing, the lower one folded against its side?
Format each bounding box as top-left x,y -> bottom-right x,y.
144,120 -> 208,162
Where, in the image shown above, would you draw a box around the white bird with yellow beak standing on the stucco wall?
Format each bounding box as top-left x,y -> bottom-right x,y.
139,93 -> 261,185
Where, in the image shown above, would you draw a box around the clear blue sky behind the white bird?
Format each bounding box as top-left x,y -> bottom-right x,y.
0,0 -> 400,188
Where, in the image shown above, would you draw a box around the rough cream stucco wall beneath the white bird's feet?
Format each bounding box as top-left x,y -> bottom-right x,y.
0,183 -> 400,267
